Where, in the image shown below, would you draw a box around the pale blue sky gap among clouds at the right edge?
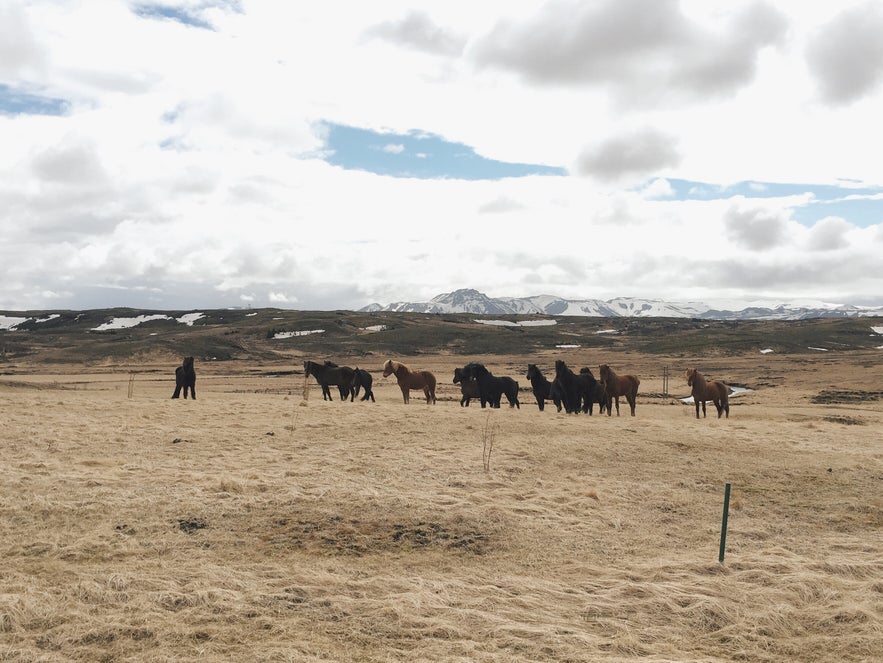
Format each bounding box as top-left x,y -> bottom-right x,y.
666,179 -> 883,227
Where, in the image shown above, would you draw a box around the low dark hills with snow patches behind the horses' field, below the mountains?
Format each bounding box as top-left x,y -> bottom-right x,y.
0,304 -> 883,366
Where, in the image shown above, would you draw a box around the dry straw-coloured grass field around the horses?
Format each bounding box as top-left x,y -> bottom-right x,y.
0,350 -> 883,662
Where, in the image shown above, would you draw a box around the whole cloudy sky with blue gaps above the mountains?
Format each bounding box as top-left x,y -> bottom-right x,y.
0,0 -> 883,311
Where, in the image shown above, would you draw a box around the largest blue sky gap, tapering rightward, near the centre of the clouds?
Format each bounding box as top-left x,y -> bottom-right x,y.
324,123 -> 567,180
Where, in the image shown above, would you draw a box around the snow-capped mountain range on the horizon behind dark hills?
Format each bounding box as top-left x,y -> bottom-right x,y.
361,289 -> 883,320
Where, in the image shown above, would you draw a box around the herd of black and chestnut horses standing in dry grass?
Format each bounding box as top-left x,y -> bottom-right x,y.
284,358 -> 730,419
